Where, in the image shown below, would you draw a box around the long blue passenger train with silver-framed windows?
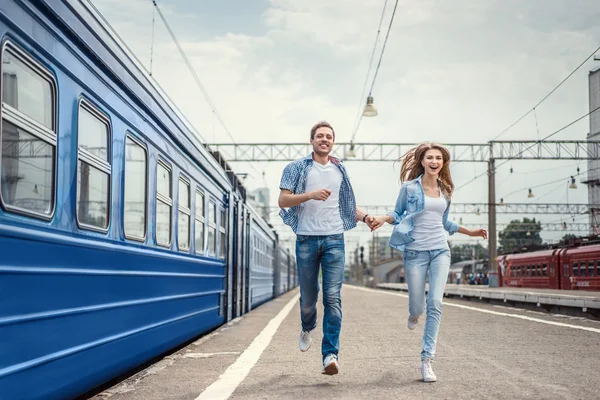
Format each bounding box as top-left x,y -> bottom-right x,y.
0,0 -> 297,400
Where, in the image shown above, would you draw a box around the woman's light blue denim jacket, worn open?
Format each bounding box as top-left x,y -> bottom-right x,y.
388,175 -> 459,251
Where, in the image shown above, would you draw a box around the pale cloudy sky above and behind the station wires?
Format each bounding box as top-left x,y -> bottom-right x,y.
91,0 -> 600,255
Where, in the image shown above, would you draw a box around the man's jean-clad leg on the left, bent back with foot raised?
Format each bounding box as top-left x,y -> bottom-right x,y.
296,235 -> 321,332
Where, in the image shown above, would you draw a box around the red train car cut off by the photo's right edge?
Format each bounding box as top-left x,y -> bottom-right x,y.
560,244 -> 600,290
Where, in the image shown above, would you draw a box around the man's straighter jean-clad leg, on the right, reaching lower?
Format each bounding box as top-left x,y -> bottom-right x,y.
321,234 -> 345,359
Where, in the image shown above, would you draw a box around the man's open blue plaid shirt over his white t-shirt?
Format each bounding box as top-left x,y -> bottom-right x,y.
279,153 -> 356,233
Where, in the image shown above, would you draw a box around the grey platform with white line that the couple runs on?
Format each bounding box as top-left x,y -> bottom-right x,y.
89,286 -> 600,400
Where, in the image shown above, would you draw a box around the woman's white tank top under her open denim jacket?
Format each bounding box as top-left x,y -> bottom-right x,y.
406,189 -> 449,251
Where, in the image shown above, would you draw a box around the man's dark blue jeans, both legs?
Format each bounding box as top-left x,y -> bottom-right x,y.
296,233 -> 345,359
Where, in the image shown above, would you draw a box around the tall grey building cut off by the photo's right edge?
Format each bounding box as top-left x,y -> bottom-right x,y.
582,67 -> 600,234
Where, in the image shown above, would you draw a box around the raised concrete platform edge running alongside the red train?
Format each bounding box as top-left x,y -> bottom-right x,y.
377,283 -> 600,312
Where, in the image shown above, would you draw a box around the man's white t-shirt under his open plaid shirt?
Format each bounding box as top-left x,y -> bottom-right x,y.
296,161 -> 344,236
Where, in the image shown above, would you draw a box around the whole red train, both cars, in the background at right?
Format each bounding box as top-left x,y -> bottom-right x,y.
497,244 -> 600,291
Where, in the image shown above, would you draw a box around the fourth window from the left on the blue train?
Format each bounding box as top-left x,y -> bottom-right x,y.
156,161 -> 173,247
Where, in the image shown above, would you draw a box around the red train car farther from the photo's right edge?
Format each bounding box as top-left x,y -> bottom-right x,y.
497,249 -> 560,289
